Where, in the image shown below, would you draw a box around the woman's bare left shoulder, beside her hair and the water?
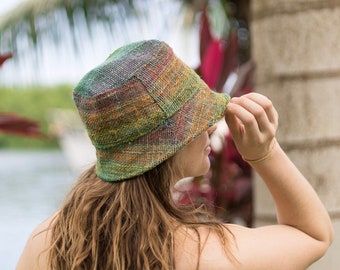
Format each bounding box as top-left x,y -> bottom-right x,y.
16,214 -> 56,270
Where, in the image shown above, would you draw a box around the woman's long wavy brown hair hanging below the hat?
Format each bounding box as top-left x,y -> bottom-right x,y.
49,161 -> 231,270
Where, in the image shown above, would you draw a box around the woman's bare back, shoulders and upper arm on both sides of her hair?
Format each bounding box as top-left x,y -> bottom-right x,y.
16,213 -> 330,270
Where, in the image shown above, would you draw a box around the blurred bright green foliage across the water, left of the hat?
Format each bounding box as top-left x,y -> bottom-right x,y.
0,85 -> 75,149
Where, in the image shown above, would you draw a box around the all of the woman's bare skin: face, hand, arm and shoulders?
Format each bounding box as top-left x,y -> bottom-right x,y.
16,93 -> 333,270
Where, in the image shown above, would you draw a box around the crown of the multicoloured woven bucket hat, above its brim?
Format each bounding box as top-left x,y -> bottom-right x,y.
74,40 -> 202,149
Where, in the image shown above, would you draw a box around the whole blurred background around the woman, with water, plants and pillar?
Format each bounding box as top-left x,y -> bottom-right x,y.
0,0 -> 340,270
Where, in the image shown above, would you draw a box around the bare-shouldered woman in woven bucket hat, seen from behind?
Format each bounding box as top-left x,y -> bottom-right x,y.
17,40 -> 333,270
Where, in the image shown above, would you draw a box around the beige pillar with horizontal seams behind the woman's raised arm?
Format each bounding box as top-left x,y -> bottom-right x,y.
250,0 -> 340,270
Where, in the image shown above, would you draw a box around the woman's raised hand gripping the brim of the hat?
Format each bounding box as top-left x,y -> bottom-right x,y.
225,93 -> 278,160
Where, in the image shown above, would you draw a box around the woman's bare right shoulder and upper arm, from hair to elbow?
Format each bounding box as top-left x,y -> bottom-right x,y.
175,224 -> 320,270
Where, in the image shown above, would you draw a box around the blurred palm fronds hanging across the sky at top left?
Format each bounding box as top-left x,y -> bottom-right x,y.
0,0 -> 194,52
